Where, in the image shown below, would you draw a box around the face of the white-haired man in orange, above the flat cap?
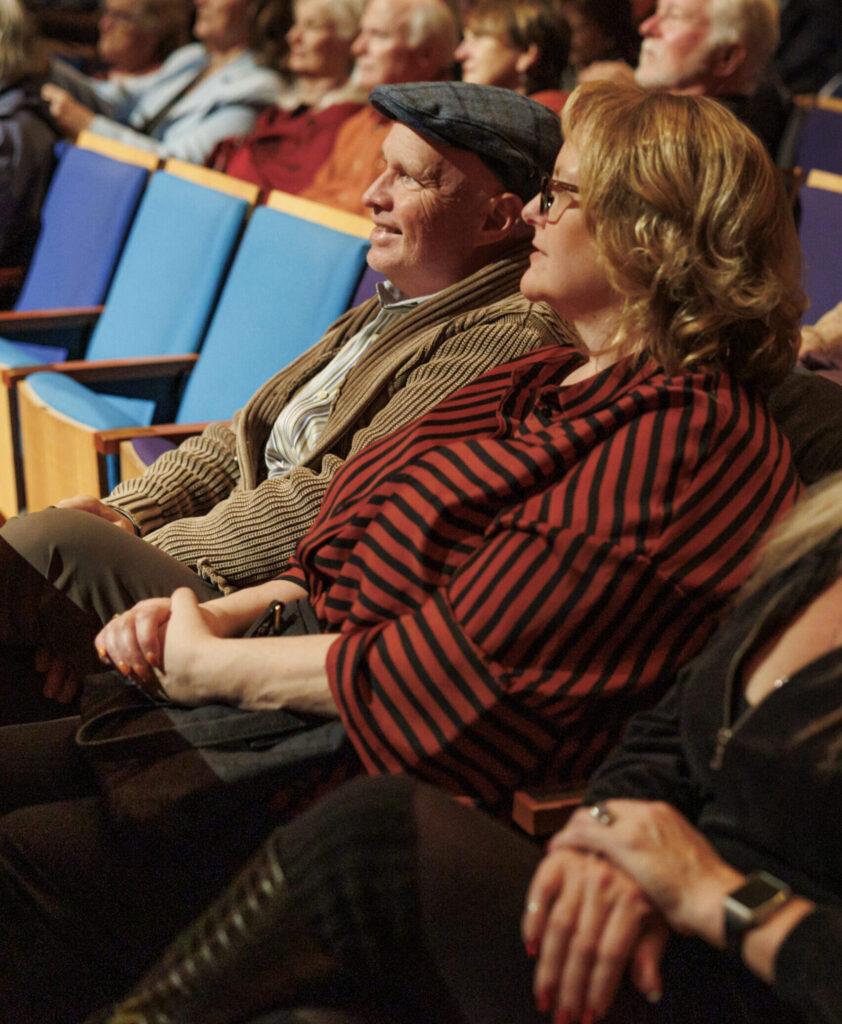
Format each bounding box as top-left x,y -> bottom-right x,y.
351,0 -> 425,89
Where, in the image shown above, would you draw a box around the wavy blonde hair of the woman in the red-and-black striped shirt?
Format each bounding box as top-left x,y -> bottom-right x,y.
562,82 -> 807,383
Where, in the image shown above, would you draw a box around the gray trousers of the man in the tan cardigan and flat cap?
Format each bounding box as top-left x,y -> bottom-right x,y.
0,508 -> 220,725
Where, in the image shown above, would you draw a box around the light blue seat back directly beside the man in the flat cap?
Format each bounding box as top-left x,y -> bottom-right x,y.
177,207 -> 369,423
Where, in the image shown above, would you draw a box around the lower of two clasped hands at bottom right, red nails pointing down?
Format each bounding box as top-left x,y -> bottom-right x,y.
521,847 -> 667,1021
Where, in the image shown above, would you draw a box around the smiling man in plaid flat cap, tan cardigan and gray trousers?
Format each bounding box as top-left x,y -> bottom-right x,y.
0,82 -> 564,722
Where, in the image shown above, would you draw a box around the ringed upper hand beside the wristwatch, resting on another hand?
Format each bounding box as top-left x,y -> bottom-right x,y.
550,800 -> 745,947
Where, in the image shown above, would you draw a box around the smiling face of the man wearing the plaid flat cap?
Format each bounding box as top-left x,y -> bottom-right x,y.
363,124 -> 502,298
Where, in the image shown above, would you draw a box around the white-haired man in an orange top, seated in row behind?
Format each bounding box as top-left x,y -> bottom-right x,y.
301,0 -> 459,214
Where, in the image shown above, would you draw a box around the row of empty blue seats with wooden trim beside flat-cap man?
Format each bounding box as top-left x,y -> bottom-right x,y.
0,136 -> 371,516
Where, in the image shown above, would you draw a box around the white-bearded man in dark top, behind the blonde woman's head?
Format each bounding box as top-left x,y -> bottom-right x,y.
580,0 -> 791,157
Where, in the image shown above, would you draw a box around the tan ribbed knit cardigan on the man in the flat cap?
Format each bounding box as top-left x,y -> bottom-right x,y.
108,246 -> 569,590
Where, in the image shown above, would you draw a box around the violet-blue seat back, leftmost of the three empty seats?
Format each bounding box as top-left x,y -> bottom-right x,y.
14,146 -> 149,310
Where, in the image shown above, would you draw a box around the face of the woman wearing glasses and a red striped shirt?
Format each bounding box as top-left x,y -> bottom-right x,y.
520,141 -> 618,324
